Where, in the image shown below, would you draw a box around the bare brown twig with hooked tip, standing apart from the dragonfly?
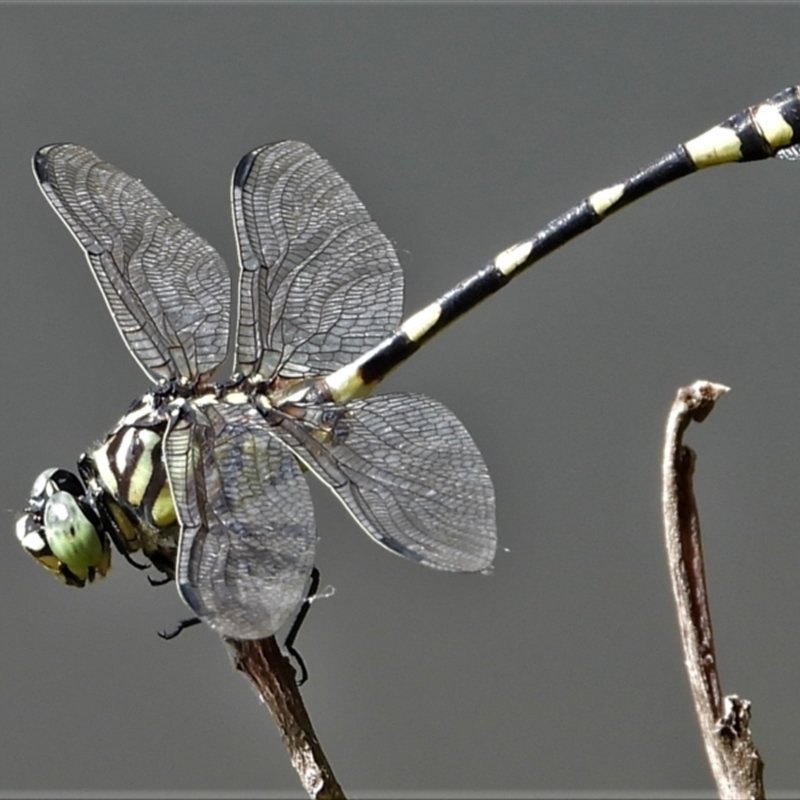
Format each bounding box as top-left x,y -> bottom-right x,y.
662,381 -> 764,800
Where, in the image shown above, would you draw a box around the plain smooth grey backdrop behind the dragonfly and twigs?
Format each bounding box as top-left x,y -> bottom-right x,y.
0,4 -> 800,793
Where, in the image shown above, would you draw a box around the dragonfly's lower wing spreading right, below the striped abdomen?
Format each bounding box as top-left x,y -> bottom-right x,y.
276,394 -> 497,572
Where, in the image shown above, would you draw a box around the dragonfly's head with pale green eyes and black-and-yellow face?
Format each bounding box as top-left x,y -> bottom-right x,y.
16,469 -> 111,586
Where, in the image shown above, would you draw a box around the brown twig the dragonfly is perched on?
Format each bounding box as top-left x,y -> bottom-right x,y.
225,636 -> 345,800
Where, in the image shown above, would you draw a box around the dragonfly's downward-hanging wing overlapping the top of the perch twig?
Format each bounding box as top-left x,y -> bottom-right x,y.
166,403 -> 316,639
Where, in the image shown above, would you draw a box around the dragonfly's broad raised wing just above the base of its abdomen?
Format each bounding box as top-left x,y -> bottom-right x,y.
232,141 -> 403,377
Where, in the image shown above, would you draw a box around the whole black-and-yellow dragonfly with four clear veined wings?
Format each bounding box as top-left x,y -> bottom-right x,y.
16,87 -> 800,639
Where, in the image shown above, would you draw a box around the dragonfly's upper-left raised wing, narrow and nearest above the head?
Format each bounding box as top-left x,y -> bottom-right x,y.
33,144 -> 231,380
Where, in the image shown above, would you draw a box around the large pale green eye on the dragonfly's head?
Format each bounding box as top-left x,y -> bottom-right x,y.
44,492 -> 108,580
